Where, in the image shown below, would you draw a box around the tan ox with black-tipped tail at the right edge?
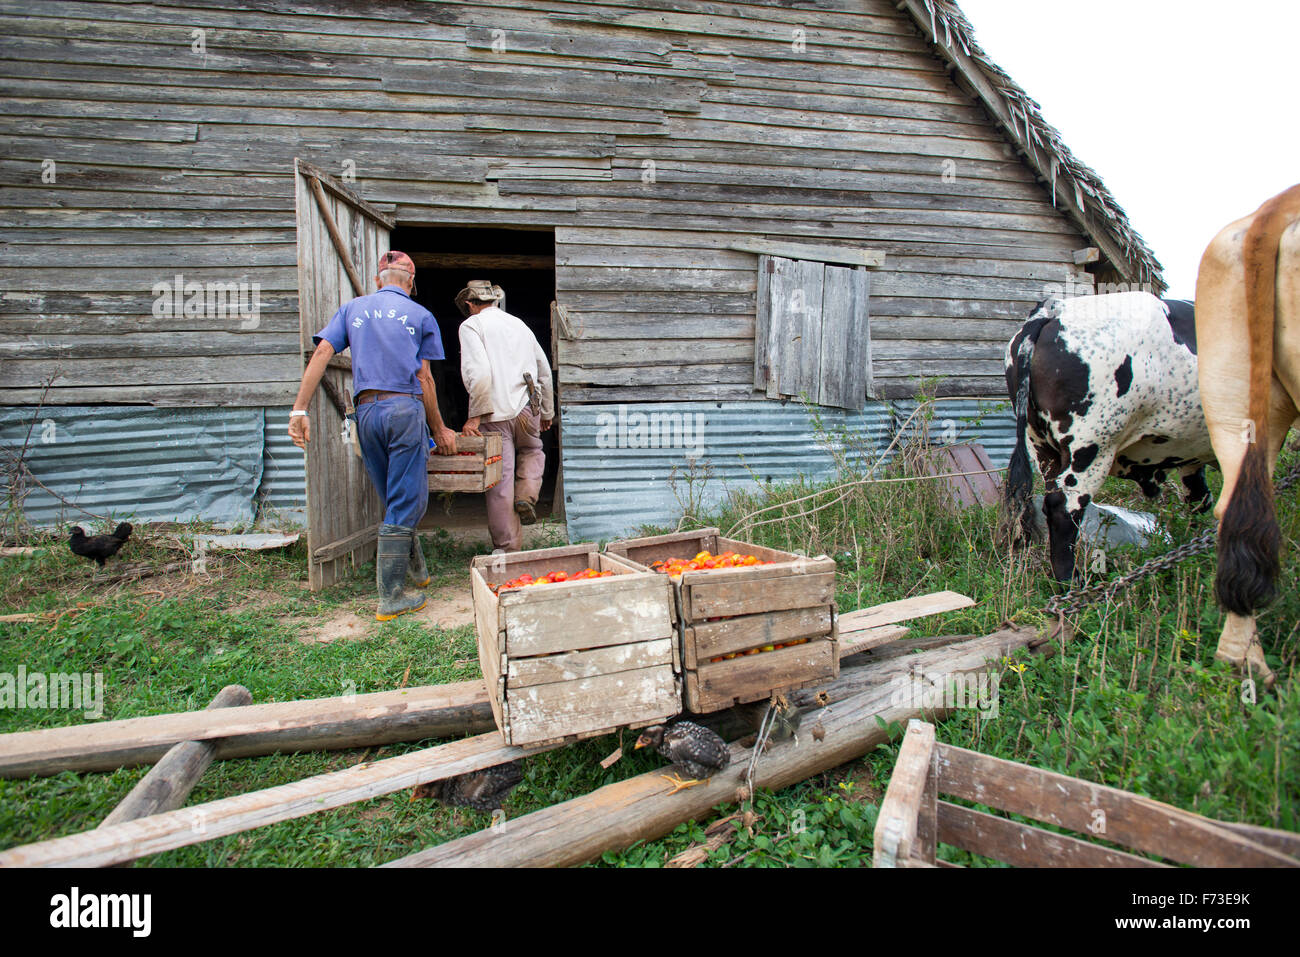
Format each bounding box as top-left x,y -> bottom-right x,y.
1196,186 -> 1300,684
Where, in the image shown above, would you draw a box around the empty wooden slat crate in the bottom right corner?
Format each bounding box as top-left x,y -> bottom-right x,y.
874,719 -> 1300,867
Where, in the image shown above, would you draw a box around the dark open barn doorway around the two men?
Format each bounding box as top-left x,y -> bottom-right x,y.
391,224 -> 560,533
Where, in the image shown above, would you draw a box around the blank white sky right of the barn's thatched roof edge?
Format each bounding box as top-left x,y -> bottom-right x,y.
958,0 -> 1300,299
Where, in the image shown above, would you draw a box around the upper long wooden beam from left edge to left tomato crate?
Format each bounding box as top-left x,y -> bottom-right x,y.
0,681 -> 497,778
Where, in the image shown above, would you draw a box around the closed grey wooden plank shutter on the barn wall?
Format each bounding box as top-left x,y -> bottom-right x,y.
754,256 -> 871,411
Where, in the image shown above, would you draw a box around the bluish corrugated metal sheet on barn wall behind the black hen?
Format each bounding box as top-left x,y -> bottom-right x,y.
0,406 -> 265,525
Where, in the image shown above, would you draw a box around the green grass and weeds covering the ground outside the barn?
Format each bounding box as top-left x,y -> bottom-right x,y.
0,421 -> 1300,866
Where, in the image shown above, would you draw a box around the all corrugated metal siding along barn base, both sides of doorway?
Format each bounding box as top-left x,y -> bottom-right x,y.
0,399 -> 1015,541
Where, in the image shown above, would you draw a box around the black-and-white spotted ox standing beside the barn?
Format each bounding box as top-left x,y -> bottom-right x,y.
1006,293 -> 1214,583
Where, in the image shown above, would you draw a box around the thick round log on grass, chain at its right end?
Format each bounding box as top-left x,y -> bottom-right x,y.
385,628 -> 1037,867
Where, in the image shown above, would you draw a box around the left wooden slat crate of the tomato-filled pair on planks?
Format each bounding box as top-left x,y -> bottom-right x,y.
469,545 -> 681,745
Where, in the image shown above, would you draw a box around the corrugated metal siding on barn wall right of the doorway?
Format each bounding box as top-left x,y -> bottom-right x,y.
563,399 -> 1015,541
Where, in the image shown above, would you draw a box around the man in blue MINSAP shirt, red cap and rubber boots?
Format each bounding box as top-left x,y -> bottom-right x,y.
289,251 -> 456,622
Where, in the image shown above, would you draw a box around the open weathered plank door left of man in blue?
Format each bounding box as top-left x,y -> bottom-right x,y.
294,160 -> 393,592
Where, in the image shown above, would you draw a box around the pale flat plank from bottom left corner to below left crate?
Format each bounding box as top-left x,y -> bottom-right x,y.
0,731 -> 549,867
